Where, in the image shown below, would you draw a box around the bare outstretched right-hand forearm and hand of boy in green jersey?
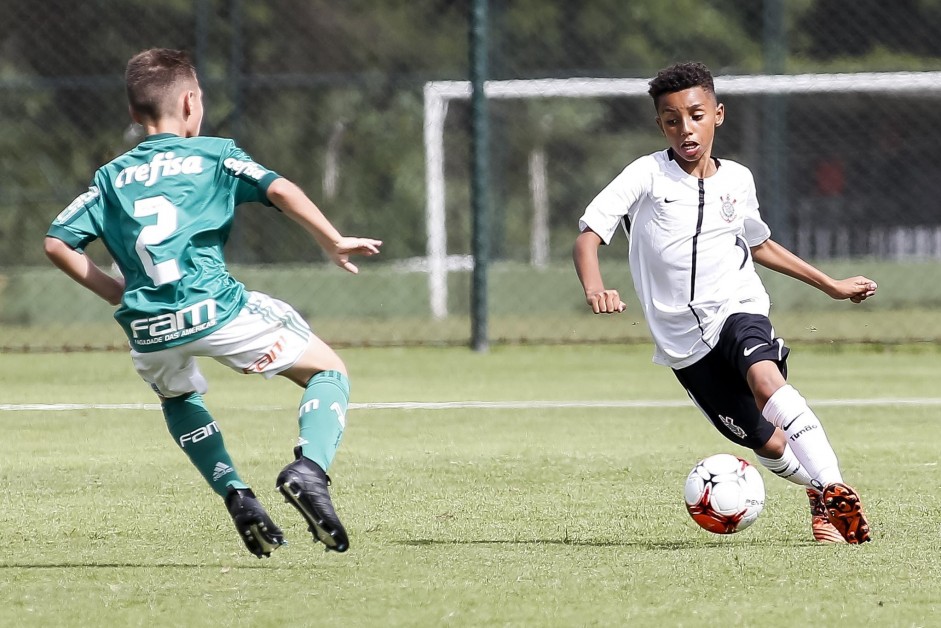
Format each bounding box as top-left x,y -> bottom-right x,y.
268,177 -> 382,274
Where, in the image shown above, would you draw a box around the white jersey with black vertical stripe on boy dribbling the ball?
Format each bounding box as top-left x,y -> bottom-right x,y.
579,150 -> 771,368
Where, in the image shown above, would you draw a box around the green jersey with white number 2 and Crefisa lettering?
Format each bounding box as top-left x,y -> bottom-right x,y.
47,133 -> 279,352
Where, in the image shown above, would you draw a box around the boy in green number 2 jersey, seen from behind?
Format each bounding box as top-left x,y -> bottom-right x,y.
45,49 -> 381,558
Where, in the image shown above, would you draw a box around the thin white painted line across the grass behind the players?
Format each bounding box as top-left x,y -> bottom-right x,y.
0,397 -> 941,412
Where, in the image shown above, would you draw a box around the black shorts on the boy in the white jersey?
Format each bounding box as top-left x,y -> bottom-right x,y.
673,314 -> 790,449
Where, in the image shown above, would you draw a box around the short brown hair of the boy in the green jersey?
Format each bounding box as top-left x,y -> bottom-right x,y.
124,48 -> 198,120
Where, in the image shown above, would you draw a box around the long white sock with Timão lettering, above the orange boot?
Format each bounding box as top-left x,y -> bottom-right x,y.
762,384 -> 843,490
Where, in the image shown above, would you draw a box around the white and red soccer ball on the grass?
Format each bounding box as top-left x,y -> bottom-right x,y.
683,454 -> 765,534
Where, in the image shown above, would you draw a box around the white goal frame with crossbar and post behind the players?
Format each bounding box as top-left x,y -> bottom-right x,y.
424,72 -> 941,318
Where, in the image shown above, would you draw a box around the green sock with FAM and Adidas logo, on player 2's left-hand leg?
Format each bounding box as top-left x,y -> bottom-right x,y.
163,393 -> 248,497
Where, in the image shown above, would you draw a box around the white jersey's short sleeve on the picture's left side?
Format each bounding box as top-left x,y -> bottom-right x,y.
578,156 -> 653,244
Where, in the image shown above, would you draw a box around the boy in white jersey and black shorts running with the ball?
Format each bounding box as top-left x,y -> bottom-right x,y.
573,63 -> 876,544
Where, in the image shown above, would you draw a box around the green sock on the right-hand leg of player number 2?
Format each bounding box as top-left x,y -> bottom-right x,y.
297,371 -> 350,471
